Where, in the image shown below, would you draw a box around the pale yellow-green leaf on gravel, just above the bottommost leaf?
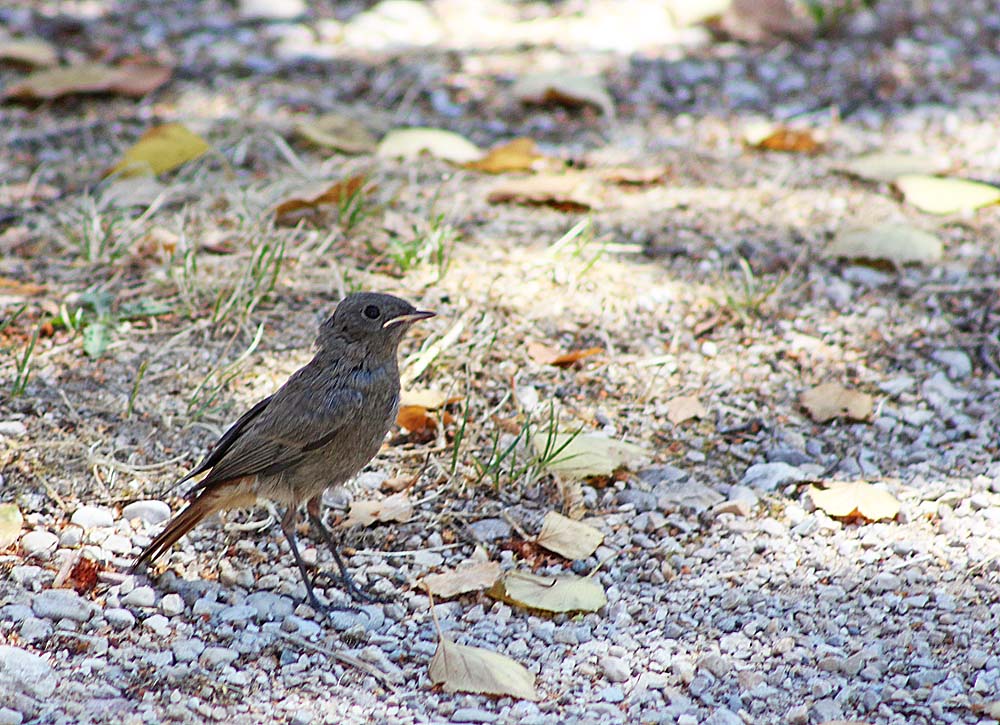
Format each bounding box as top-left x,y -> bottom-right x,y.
487,571 -> 608,613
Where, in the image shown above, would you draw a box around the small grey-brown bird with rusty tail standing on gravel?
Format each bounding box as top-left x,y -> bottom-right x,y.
129,292 -> 434,608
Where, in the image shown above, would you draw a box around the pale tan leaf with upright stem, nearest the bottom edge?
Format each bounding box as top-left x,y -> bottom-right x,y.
428,637 -> 538,700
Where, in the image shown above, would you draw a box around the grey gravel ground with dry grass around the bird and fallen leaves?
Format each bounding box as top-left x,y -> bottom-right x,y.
0,0 -> 1000,725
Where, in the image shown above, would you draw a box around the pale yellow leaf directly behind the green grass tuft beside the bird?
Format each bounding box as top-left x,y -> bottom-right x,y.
531,431 -> 649,478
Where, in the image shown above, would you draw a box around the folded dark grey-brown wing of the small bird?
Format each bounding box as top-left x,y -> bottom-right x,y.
188,389 -> 363,496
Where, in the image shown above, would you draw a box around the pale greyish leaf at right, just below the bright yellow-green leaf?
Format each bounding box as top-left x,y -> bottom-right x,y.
823,224 -> 943,267
